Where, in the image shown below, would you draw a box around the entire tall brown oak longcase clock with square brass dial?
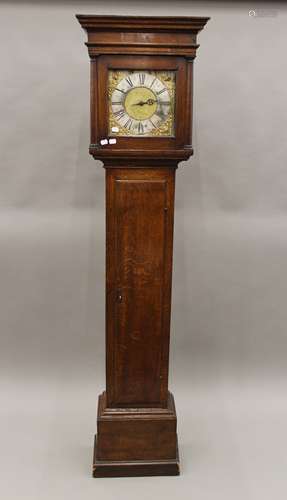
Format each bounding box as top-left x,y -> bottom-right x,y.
77,15 -> 209,477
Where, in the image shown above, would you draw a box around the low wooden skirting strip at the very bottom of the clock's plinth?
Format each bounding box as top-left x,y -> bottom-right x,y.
93,436 -> 180,477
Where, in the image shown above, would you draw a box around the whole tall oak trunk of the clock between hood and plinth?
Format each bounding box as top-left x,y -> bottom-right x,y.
107,169 -> 177,407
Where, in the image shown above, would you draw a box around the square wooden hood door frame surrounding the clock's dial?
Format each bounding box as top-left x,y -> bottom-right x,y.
93,55 -> 192,157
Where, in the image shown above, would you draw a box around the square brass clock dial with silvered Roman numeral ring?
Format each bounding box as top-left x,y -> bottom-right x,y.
109,70 -> 175,137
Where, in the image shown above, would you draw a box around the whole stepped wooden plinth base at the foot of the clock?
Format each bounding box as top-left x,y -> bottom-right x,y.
93,392 -> 179,477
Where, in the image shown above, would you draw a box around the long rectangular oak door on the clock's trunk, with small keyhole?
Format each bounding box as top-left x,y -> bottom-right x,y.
114,179 -> 166,405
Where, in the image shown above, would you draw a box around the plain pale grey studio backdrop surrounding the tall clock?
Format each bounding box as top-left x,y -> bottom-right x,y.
0,0 -> 287,500
